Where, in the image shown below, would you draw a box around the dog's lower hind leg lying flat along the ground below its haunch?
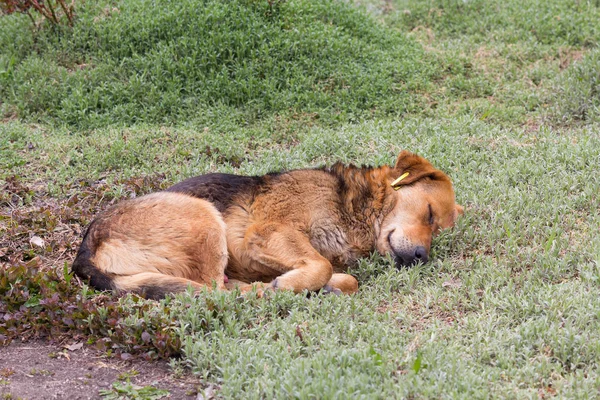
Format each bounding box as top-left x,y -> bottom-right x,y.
113,272 -> 225,300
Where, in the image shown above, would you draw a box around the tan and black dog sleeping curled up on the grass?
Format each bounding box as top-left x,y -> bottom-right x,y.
72,151 -> 463,299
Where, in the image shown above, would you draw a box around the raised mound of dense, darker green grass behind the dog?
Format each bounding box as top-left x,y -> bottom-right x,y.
0,0 -> 435,127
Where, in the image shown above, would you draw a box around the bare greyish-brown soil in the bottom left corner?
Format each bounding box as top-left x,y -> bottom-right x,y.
0,341 -> 204,400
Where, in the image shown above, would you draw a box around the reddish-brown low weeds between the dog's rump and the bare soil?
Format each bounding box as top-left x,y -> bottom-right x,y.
0,264 -> 180,358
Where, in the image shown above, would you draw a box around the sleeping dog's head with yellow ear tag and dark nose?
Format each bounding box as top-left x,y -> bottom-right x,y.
376,151 -> 463,267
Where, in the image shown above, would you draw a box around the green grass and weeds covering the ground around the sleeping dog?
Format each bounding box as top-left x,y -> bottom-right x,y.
0,0 -> 600,398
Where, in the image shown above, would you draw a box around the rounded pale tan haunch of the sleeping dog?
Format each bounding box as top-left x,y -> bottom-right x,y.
78,192 -> 227,298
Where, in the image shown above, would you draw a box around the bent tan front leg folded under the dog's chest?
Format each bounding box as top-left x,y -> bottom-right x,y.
244,224 -> 333,293
